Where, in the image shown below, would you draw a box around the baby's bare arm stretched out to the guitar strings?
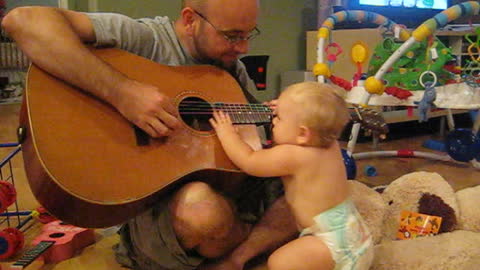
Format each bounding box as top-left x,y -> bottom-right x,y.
210,111 -> 296,177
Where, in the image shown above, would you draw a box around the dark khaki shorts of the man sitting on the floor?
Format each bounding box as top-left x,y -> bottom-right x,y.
114,178 -> 283,270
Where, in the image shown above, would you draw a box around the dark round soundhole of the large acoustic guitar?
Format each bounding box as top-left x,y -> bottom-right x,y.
179,97 -> 213,131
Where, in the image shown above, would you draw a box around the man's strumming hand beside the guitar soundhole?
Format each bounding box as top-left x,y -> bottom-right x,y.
113,81 -> 180,138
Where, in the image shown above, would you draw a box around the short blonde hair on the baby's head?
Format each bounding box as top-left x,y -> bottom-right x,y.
282,82 -> 350,147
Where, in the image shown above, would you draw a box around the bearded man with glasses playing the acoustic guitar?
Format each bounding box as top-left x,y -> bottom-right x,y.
2,0 -> 296,270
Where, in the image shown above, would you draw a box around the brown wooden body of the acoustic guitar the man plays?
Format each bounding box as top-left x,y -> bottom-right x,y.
20,49 -> 261,227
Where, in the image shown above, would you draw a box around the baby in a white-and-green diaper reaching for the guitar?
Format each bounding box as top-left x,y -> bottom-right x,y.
210,82 -> 373,270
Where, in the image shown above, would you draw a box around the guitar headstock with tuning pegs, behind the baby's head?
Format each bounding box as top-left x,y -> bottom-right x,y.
351,107 -> 388,139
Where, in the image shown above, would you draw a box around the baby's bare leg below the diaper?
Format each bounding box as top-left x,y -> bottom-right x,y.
268,235 -> 335,270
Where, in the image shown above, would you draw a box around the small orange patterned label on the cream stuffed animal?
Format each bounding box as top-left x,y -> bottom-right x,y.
397,211 -> 442,240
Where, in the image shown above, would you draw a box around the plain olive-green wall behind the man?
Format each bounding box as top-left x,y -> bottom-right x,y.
75,0 -> 317,101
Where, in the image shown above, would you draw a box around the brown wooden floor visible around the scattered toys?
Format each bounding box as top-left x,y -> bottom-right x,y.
0,104 -> 480,270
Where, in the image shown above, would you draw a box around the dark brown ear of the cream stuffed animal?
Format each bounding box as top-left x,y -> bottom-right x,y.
418,193 -> 457,233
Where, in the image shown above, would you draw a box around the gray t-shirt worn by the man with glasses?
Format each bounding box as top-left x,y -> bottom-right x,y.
86,13 -> 257,103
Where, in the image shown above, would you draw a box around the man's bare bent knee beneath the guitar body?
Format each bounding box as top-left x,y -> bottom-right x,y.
169,182 -> 251,258
